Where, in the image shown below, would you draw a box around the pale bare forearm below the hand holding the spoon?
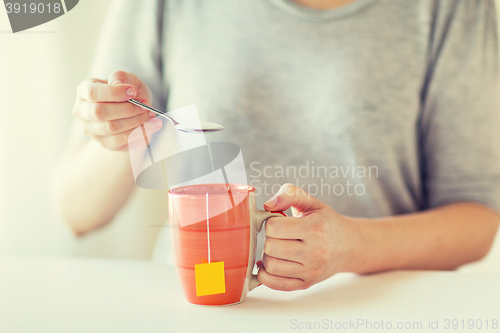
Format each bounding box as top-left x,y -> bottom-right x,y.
52,140 -> 134,235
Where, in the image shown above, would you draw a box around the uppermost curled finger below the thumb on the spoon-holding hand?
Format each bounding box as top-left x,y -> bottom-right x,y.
77,79 -> 137,103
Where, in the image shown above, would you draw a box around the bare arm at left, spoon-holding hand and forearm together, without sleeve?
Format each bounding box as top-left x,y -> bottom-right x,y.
52,71 -> 162,235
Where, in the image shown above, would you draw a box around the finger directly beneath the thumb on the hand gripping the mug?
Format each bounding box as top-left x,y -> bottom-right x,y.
266,216 -> 307,239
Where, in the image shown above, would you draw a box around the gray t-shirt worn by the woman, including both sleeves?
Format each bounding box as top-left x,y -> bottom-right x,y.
91,0 -> 500,217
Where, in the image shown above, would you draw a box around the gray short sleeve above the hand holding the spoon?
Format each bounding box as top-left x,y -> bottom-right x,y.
89,0 -> 166,108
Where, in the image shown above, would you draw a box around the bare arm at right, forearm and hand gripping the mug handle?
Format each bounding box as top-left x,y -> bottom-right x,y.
259,184 -> 500,290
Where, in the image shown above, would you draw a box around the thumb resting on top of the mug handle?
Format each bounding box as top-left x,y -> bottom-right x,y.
264,184 -> 325,212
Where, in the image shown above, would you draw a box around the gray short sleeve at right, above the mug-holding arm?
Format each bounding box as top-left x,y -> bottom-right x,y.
419,0 -> 500,211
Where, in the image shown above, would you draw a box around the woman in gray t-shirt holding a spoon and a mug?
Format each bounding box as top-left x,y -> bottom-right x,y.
51,0 -> 500,290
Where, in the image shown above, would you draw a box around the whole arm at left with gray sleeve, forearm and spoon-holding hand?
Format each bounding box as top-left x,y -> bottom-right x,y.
51,0 -> 166,234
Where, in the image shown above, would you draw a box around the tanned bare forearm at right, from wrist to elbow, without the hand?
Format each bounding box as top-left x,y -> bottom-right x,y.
344,202 -> 500,273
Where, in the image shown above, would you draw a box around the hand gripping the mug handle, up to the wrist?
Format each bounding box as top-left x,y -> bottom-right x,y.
258,184 -> 358,291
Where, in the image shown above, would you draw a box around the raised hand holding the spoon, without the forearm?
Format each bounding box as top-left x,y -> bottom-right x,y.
73,71 -> 162,150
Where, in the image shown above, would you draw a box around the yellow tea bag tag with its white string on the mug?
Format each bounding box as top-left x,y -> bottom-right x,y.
194,193 -> 226,296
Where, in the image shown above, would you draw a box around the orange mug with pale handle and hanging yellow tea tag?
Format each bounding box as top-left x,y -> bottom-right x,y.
168,184 -> 286,305
